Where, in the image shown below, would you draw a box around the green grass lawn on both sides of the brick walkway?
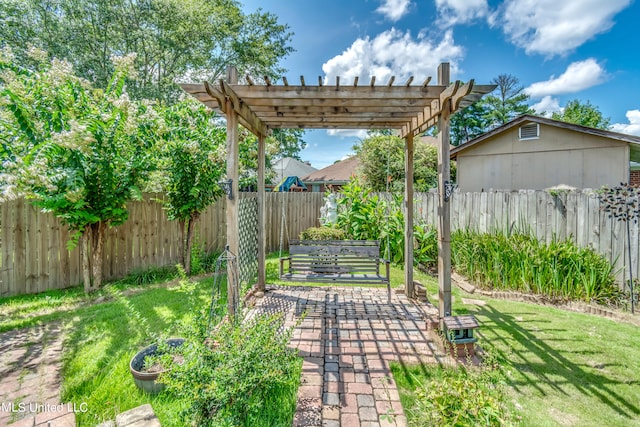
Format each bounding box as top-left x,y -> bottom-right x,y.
0,255 -> 640,427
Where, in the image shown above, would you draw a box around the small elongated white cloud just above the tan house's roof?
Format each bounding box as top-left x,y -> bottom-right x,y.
524,58 -> 607,99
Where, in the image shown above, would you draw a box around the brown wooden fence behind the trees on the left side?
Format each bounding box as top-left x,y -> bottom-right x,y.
0,193 -> 323,296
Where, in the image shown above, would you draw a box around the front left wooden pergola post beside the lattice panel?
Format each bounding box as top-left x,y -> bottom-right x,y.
225,66 -> 240,318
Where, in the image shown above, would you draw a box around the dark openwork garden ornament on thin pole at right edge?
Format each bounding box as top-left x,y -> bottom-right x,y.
600,183 -> 640,313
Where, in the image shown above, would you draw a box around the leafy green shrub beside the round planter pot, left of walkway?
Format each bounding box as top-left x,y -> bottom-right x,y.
161,316 -> 301,426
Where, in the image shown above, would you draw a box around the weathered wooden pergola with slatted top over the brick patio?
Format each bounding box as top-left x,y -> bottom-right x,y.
181,63 -> 495,319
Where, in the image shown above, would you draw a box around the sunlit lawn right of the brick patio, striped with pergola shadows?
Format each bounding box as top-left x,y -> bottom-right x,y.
396,279 -> 640,427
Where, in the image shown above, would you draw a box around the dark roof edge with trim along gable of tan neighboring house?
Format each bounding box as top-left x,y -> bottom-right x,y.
451,114 -> 640,162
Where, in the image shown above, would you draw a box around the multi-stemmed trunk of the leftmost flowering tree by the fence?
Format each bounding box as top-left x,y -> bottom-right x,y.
81,221 -> 107,292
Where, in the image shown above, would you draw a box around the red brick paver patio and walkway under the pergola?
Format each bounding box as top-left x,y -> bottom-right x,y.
252,287 -> 446,427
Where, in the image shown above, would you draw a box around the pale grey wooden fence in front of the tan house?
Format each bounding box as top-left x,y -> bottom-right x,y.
415,190 -> 640,284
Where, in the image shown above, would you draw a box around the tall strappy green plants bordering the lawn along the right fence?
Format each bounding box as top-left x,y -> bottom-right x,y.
451,230 -> 620,303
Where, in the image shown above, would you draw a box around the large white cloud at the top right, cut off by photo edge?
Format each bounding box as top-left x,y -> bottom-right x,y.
490,0 -> 632,56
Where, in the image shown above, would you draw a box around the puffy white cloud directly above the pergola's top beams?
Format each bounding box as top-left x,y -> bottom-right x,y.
322,28 -> 464,84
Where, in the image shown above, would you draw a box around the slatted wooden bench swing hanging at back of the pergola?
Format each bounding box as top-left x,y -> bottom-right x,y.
280,240 -> 390,289
